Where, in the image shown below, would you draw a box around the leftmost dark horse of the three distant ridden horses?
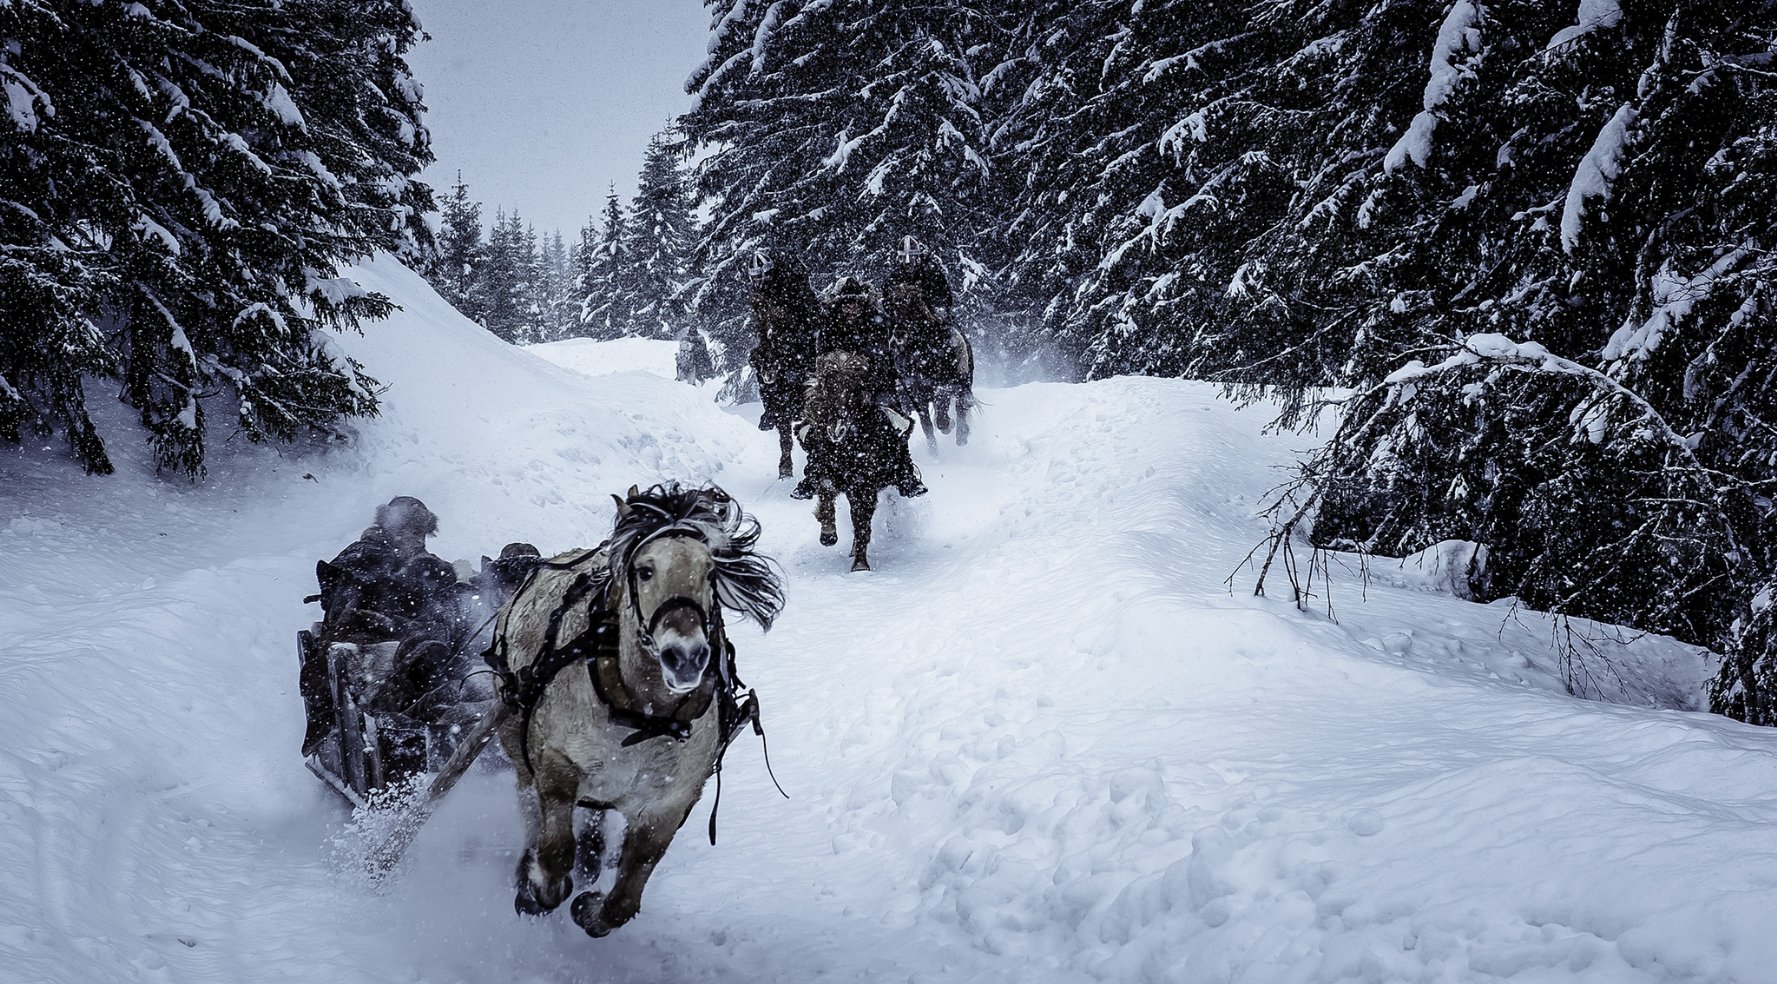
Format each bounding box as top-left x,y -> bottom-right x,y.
748,256 -> 821,478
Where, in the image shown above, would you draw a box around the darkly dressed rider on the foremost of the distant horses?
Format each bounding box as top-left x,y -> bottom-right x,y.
791,277 -> 926,499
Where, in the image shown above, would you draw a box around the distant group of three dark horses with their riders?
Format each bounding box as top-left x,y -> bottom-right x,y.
748,238 -> 974,570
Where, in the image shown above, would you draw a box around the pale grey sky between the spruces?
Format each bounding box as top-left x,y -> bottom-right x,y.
409,0 -> 709,242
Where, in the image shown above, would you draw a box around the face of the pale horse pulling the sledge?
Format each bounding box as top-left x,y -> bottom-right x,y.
629,536 -> 716,694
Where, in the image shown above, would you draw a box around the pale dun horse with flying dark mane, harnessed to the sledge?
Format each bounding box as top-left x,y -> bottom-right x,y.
489,485 -> 784,936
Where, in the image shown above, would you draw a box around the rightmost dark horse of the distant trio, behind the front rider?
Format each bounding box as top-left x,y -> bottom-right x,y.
883,284 -> 976,451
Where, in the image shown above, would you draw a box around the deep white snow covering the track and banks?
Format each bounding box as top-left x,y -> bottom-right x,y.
0,261 -> 1777,984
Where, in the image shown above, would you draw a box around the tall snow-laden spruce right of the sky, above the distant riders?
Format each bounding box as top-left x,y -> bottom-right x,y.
679,0 -> 1000,352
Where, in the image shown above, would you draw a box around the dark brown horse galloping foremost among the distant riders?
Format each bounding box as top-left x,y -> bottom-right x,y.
796,352 -> 913,570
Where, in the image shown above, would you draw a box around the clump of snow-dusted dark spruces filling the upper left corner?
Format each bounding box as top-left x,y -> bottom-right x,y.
0,0 -> 432,476
